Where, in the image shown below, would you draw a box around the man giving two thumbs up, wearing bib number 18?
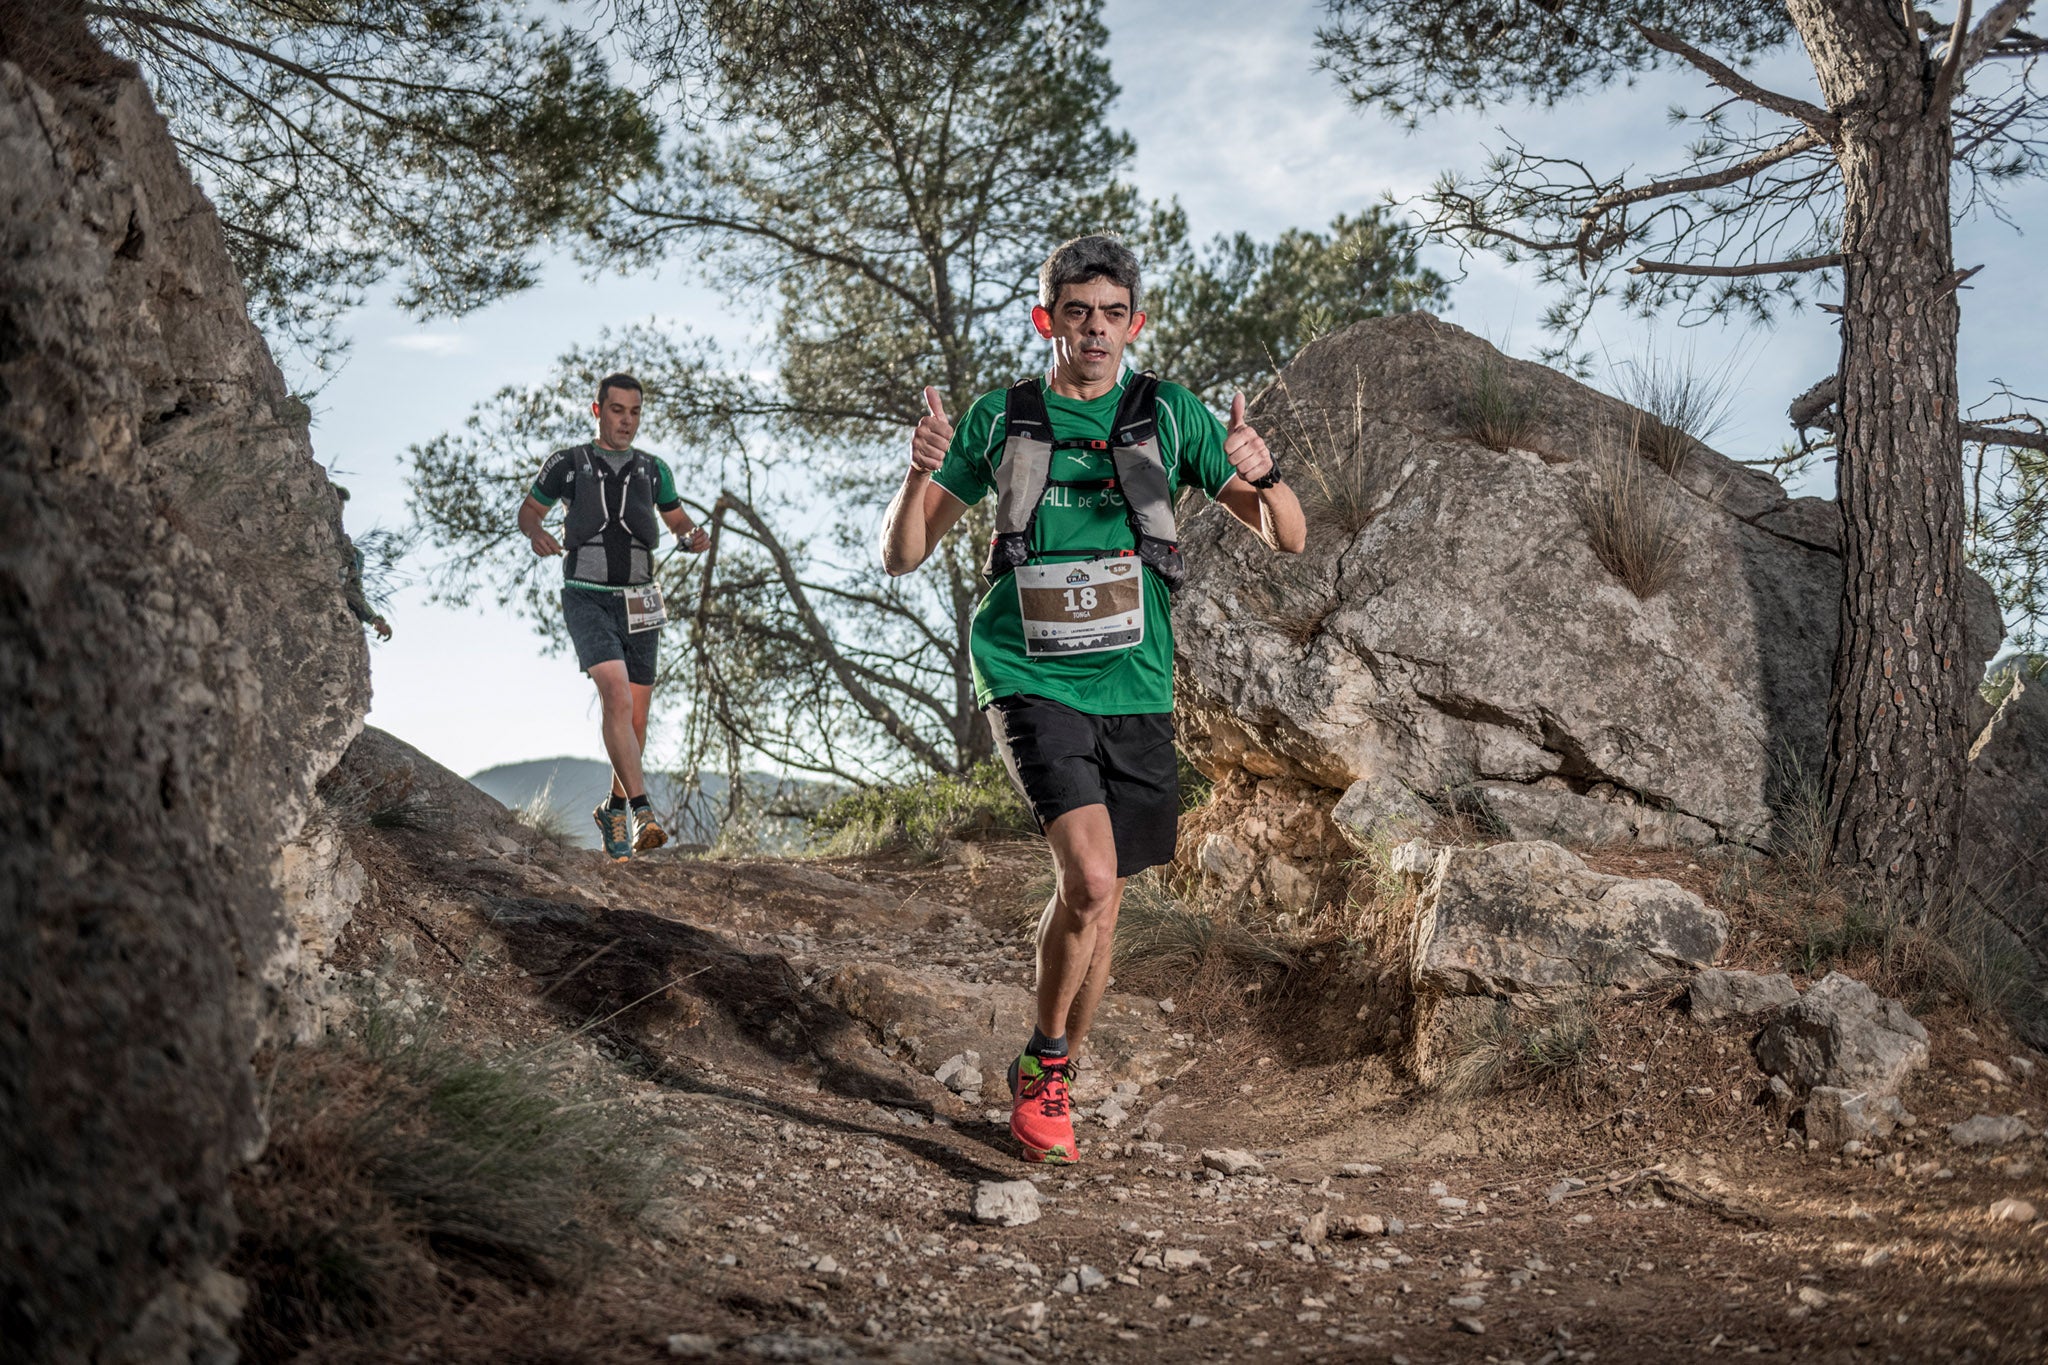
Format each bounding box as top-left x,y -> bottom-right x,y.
883,235 -> 1307,1162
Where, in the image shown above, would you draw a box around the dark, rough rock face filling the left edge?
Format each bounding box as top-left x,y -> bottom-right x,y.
0,37 -> 369,1363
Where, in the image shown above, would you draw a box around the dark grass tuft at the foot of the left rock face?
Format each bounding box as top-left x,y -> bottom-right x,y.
227,1009 -> 651,1361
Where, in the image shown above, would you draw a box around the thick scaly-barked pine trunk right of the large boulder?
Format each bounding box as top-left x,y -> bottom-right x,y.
1788,0 -> 1970,917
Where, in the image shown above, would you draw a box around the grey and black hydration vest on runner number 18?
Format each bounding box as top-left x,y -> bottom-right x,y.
981,370 -> 1184,589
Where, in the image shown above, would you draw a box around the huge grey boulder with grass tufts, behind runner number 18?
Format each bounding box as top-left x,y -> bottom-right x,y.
1174,313 -> 2001,847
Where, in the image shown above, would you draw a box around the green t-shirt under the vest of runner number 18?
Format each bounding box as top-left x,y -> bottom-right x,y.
934,370 -> 1237,716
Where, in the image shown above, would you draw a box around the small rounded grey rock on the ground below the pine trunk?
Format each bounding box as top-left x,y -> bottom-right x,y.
1755,972 -> 1927,1095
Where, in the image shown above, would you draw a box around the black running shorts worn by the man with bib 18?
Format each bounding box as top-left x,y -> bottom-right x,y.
987,696 -> 1180,876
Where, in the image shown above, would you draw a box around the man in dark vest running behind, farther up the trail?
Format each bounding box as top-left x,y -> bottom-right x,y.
518,375 -> 711,860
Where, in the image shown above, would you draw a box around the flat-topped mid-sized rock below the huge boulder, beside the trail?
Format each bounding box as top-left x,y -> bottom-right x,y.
1411,843 -> 1729,999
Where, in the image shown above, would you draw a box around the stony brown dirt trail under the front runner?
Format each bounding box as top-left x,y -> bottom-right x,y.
307,810 -> 2048,1365
